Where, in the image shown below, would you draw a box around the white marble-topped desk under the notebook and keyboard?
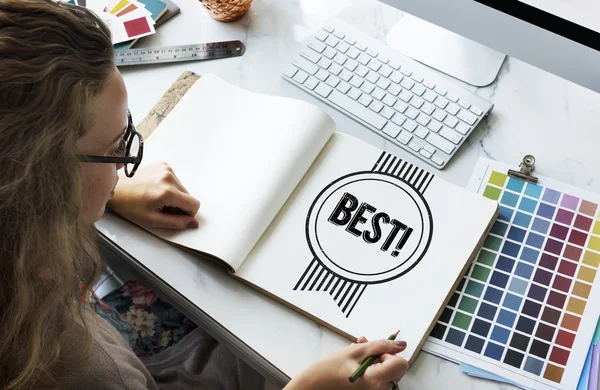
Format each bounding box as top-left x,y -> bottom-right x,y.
97,0 -> 600,390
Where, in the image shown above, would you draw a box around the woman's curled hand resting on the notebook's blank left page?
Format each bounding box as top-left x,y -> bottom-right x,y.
108,163 -> 200,229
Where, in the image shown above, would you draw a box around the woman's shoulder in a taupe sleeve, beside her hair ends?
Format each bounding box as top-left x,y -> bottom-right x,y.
60,312 -> 158,390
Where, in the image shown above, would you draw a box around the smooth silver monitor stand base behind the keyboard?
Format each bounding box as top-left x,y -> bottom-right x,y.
387,13 -> 506,87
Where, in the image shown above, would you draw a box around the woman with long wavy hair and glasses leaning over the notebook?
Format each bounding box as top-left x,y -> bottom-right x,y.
0,0 -> 407,389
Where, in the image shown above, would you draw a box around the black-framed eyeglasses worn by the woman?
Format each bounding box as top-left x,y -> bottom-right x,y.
77,110 -> 144,177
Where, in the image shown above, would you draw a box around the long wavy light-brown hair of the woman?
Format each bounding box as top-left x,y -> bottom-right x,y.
0,0 -> 114,389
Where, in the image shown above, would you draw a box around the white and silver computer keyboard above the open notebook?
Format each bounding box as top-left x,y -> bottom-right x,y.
283,19 -> 493,169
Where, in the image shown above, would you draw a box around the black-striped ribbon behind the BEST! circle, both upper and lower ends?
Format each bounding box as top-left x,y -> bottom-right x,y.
294,152 -> 433,318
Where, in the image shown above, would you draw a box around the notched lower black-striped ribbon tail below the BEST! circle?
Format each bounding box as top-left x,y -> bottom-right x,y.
294,259 -> 367,318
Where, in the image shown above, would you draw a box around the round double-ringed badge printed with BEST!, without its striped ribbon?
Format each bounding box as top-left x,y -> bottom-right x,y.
306,172 -> 433,284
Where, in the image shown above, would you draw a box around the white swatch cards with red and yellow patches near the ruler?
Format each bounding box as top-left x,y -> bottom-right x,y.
75,0 -> 157,45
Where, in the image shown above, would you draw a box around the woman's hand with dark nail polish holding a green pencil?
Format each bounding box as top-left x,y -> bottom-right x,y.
285,337 -> 408,390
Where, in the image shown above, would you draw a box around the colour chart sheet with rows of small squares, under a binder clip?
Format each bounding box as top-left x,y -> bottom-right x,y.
424,158 -> 600,389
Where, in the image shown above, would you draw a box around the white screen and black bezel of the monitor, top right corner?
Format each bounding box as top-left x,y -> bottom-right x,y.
475,0 -> 600,50
